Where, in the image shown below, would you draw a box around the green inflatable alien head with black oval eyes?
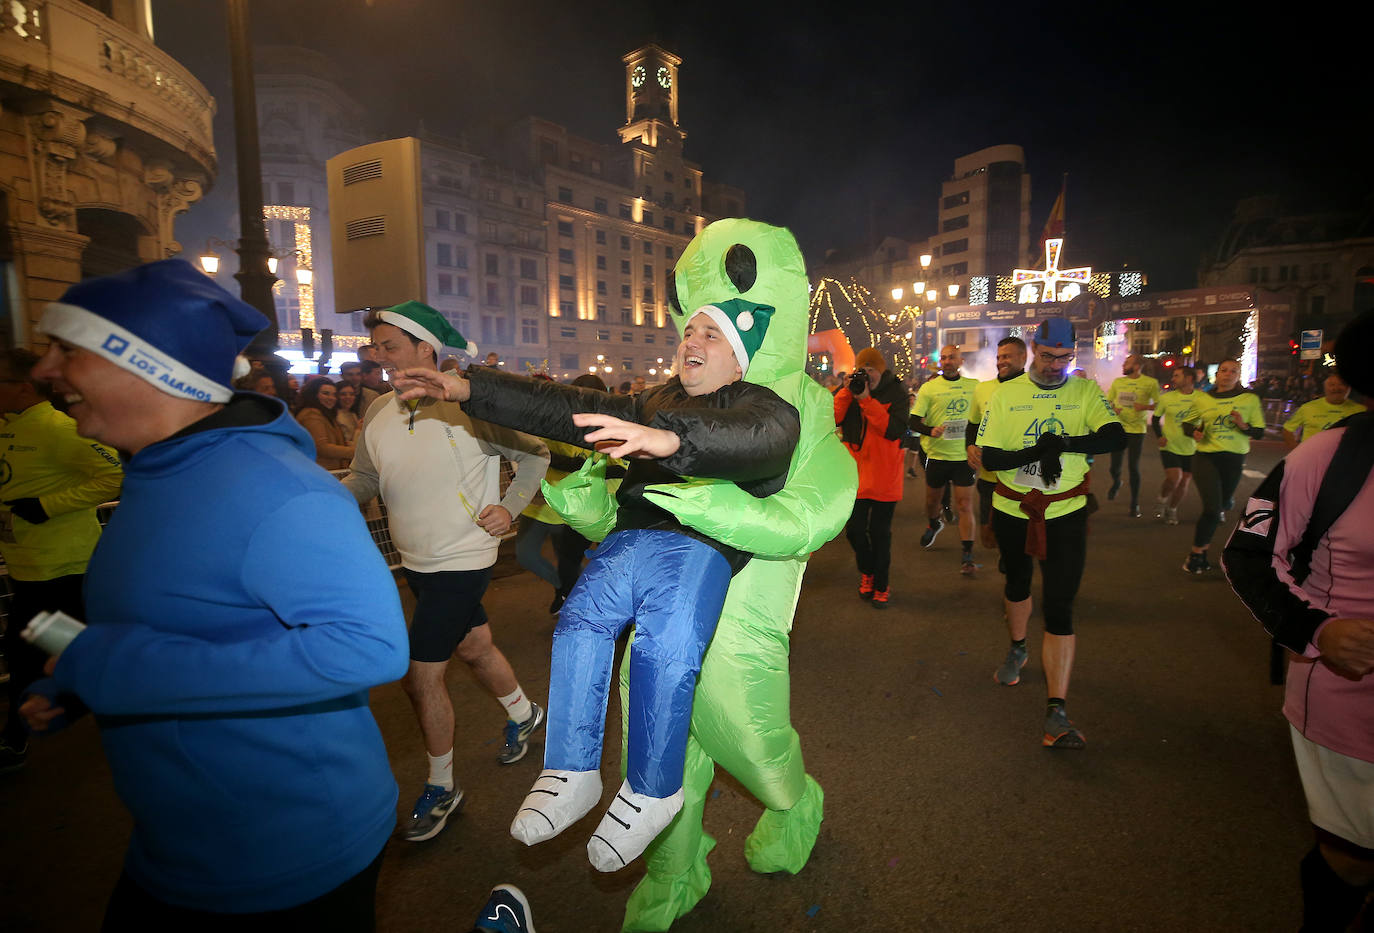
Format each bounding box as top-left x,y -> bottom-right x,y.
668,218 -> 808,385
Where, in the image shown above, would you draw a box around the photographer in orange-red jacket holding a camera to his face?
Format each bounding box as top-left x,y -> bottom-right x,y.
835,346 -> 911,609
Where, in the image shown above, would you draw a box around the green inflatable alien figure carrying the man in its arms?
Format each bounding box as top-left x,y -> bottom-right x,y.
545,220 -> 857,932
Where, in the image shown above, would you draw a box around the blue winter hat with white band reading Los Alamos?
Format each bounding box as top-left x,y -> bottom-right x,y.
38,260 -> 268,403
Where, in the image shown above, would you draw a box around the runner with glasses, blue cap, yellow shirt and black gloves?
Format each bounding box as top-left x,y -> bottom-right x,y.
978,317 -> 1125,749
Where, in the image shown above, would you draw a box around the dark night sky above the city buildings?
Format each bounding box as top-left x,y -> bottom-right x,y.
154,0 -> 1374,290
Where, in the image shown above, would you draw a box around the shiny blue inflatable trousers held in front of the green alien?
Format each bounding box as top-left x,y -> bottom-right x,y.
544,529 -> 730,797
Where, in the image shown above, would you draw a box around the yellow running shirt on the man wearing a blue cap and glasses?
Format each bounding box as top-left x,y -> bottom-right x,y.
978,375 -> 1121,519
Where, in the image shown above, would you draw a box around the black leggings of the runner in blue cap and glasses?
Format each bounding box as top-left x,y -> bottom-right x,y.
992,508 -> 1088,635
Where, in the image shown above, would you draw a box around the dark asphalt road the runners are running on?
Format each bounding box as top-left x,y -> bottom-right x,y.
0,442 -> 1311,933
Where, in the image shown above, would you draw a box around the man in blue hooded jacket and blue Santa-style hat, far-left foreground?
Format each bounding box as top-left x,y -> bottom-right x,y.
23,260 -> 407,930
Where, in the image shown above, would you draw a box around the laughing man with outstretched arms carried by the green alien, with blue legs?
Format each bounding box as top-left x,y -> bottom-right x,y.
396,281 -> 800,871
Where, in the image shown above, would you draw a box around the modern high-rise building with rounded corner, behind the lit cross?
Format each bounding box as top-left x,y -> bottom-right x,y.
930,146 -> 1031,291
